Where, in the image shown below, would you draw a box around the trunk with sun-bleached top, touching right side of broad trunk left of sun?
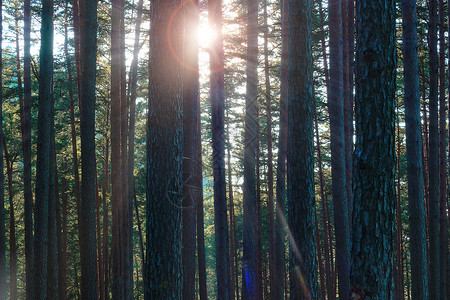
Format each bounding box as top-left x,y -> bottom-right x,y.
182,0 -> 201,300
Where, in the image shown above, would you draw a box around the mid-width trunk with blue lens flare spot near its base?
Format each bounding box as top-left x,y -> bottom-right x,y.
242,0 -> 256,300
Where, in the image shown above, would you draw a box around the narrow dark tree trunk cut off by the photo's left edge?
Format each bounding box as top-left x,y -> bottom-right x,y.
0,0 -> 6,300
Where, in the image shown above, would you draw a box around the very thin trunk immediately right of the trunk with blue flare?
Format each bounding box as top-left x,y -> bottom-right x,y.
264,0 -> 275,299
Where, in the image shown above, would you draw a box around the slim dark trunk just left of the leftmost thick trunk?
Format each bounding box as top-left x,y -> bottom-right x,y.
23,0 -> 34,299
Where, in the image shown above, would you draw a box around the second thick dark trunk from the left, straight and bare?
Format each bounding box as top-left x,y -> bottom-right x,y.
80,1 -> 98,299
